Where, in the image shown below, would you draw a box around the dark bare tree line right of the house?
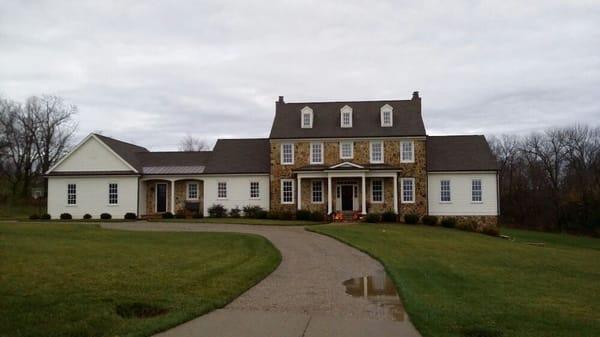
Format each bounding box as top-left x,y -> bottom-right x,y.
489,125 -> 600,234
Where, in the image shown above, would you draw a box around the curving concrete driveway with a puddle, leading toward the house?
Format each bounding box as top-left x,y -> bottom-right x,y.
102,222 -> 420,337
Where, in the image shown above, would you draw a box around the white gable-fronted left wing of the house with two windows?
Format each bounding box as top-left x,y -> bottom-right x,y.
47,134 -> 138,219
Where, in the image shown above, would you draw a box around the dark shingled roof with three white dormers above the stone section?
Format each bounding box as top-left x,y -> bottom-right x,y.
270,96 -> 425,139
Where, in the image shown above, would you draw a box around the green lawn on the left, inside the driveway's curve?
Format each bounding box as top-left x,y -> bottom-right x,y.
0,222 -> 281,337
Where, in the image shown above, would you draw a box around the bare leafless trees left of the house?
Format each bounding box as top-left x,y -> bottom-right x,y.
0,96 -> 77,199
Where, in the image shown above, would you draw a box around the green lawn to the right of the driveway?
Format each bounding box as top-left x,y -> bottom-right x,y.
310,224 -> 600,337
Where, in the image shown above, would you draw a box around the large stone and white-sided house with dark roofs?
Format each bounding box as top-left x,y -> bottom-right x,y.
47,92 -> 499,225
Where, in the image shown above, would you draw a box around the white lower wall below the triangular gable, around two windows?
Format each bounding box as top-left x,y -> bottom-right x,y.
48,176 -> 138,219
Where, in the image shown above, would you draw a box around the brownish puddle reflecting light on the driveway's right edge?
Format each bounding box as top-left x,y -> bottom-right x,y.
342,271 -> 408,321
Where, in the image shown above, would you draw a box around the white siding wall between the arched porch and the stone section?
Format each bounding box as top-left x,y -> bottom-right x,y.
202,175 -> 270,216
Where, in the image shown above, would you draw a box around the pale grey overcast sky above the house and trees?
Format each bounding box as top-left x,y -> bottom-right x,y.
0,0 -> 600,150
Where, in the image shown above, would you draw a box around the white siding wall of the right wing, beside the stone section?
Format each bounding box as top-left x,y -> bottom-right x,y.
427,172 -> 498,215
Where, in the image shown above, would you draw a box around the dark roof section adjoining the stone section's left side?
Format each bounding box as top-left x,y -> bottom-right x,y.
204,138 -> 270,174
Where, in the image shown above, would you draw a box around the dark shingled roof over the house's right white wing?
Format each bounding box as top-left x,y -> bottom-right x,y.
427,135 -> 498,172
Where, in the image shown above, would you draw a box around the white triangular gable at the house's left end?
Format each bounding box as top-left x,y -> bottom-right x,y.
54,137 -> 131,171
